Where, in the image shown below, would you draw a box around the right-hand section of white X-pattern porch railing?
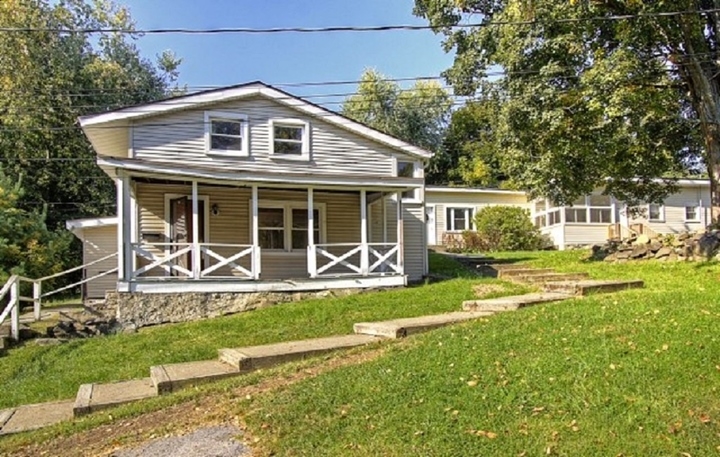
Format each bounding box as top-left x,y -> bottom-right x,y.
308,243 -> 403,278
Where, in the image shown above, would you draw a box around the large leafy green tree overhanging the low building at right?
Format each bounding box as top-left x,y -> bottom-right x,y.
415,0 -> 704,205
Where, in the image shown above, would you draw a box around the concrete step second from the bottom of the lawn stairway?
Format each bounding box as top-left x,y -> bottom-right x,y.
73,378 -> 157,417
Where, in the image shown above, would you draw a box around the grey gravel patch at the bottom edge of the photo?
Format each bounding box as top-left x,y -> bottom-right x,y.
112,425 -> 250,457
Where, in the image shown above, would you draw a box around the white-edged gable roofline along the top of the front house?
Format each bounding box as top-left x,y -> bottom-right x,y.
79,81 -> 433,159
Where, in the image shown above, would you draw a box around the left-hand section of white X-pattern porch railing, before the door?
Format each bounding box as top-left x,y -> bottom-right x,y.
132,243 -> 260,279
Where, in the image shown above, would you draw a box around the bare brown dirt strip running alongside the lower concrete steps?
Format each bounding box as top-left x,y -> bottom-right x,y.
5,347 -> 385,457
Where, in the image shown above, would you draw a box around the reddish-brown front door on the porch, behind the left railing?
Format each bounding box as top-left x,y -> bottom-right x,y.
170,197 -> 205,275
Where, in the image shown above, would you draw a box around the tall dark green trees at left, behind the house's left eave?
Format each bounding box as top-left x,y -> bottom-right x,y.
0,0 -> 180,229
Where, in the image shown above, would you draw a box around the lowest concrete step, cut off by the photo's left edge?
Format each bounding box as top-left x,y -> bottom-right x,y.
0,400 -> 73,435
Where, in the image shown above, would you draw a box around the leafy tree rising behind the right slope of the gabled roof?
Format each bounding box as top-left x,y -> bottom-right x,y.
341,70 -> 452,182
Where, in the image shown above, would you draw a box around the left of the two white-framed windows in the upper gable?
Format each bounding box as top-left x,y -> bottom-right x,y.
205,111 -> 250,156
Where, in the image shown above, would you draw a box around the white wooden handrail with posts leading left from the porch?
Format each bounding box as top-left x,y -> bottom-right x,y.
0,252 -> 118,341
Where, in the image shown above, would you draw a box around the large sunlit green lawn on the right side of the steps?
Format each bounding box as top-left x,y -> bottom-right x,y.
246,251 -> 720,456
